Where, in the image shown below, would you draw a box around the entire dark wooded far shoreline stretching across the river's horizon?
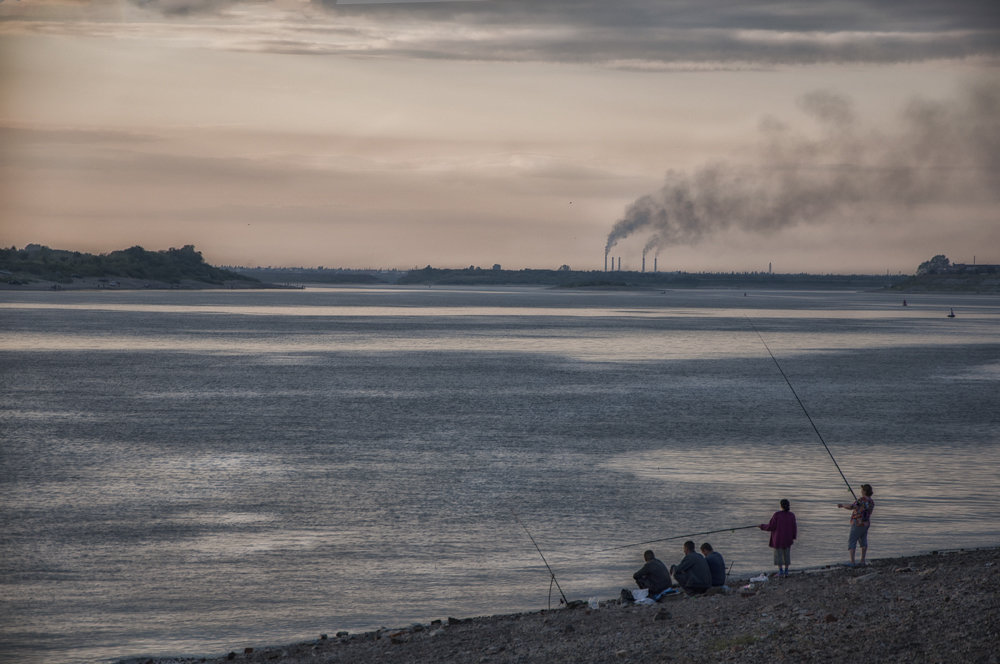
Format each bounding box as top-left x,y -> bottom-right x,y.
9,244 -> 1000,293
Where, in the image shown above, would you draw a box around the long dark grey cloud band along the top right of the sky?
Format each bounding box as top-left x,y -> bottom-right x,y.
119,0 -> 1000,68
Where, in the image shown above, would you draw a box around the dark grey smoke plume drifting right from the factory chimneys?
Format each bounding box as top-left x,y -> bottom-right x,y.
605,83 -> 1000,256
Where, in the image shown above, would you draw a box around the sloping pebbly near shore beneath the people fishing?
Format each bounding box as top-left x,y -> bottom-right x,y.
120,549 -> 1000,664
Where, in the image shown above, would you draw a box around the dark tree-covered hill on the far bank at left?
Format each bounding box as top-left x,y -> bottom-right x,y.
0,244 -> 259,287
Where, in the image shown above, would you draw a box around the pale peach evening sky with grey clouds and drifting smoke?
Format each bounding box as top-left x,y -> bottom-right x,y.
0,0 -> 1000,274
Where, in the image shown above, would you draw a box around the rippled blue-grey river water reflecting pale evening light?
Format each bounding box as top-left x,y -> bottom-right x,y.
0,287 -> 1000,663
